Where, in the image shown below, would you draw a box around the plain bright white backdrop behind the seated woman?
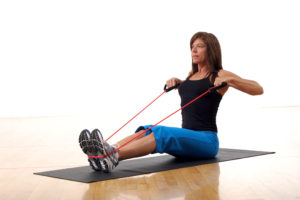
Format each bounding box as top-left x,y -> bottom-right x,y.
0,0 -> 300,117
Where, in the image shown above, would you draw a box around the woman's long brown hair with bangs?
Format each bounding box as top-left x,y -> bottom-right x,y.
188,32 -> 223,82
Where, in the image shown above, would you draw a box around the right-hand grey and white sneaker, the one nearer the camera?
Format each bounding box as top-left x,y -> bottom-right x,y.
90,129 -> 119,172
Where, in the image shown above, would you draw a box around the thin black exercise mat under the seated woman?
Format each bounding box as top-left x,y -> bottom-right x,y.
34,148 -> 275,183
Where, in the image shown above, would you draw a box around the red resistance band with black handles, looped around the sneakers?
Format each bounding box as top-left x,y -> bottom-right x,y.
88,82 -> 227,158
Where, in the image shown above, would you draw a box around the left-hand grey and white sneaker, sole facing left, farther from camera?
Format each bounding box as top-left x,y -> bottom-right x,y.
79,129 -> 102,171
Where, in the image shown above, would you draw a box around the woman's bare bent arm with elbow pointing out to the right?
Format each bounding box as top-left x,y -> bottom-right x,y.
214,70 -> 264,95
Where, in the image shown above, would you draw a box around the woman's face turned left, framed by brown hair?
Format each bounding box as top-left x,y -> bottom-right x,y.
191,38 -> 206,64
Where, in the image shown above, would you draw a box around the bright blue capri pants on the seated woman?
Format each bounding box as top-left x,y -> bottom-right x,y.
136,125 -> 219,158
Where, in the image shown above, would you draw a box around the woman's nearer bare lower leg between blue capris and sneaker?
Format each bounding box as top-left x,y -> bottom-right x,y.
118,132 -> 156,161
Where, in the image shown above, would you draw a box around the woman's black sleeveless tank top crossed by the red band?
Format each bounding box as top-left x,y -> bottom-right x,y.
178,78 -> 222,132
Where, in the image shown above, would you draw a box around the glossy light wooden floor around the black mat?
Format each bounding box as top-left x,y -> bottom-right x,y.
0,107 -> 300,200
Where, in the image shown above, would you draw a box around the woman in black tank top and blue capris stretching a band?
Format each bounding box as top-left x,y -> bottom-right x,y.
79,32 -> 263,172
